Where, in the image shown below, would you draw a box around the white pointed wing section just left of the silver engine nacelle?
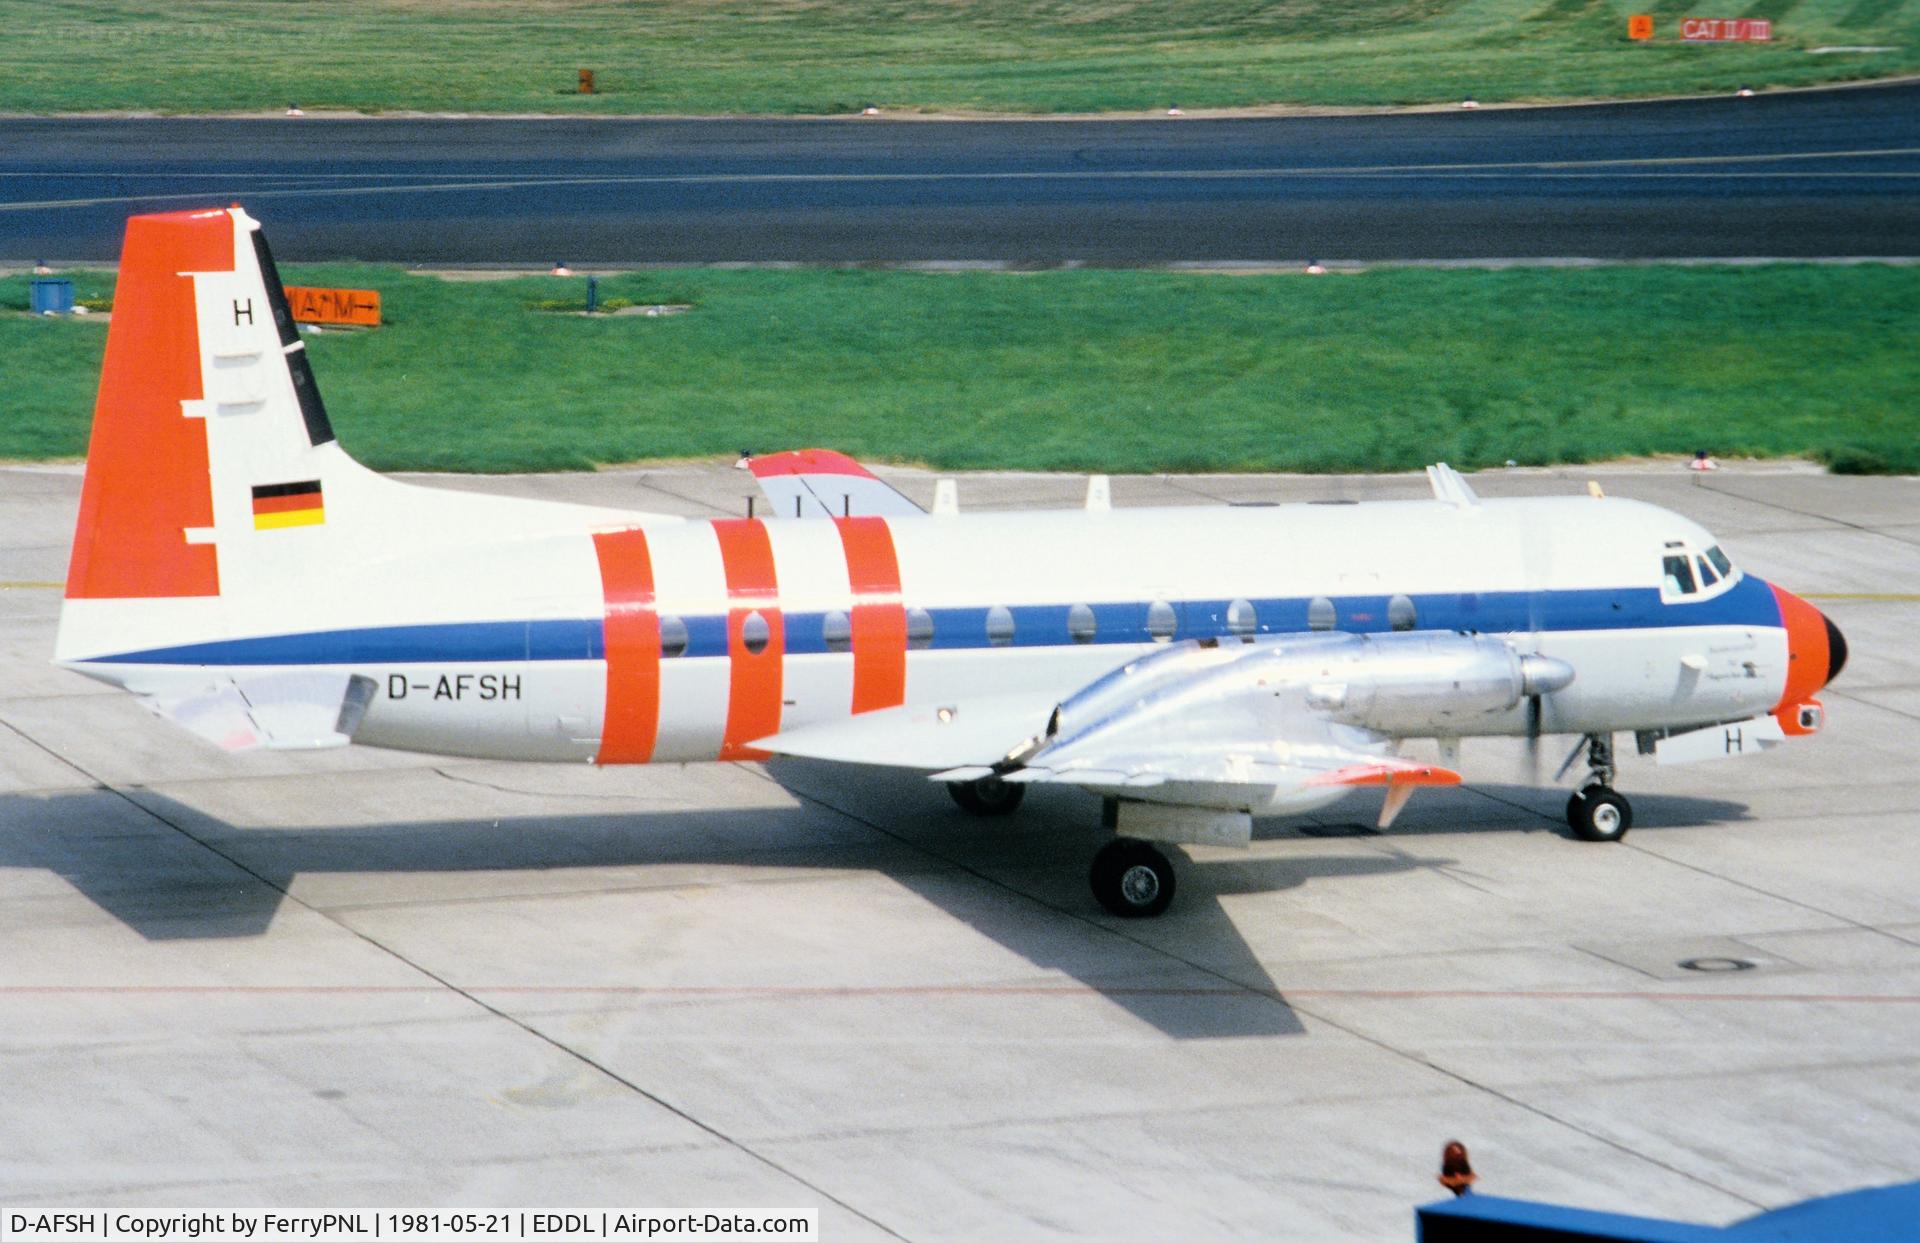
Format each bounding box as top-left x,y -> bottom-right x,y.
753,694 -> 1060,780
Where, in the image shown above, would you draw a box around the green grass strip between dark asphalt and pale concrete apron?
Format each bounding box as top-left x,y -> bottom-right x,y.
0,265 -> 1920,473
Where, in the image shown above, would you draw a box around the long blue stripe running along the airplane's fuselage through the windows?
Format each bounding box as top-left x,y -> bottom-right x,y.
82,576 -> 1780,665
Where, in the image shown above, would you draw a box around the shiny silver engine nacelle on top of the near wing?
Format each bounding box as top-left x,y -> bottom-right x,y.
1008,634 -> 1574,765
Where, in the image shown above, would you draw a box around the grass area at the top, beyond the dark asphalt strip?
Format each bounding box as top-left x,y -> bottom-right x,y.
11,0 -> 1920,115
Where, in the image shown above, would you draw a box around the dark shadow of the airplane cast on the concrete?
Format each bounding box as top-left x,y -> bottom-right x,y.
0,783 -> 1745,1039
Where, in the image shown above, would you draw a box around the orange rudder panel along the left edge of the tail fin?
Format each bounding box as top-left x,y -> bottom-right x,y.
67,211 -> 234,599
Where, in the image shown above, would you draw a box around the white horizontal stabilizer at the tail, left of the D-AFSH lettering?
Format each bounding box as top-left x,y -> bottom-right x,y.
140,670 -> 374,751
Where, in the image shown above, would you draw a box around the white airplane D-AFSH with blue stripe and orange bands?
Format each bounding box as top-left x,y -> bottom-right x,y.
54,206 -> 1847,916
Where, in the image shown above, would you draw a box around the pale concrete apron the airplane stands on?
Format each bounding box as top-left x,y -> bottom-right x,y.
0,465 -> 1920,1241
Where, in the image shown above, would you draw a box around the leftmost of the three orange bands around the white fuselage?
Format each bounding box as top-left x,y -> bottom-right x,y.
593,530 -> 660,765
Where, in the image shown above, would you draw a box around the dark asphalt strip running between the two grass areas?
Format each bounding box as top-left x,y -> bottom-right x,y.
0,85 -> 1920,265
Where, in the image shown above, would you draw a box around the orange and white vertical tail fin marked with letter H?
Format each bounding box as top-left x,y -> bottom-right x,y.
67,207 -> 359,599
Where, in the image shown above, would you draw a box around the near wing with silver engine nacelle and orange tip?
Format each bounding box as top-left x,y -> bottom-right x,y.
755,634 -> 1572,828
